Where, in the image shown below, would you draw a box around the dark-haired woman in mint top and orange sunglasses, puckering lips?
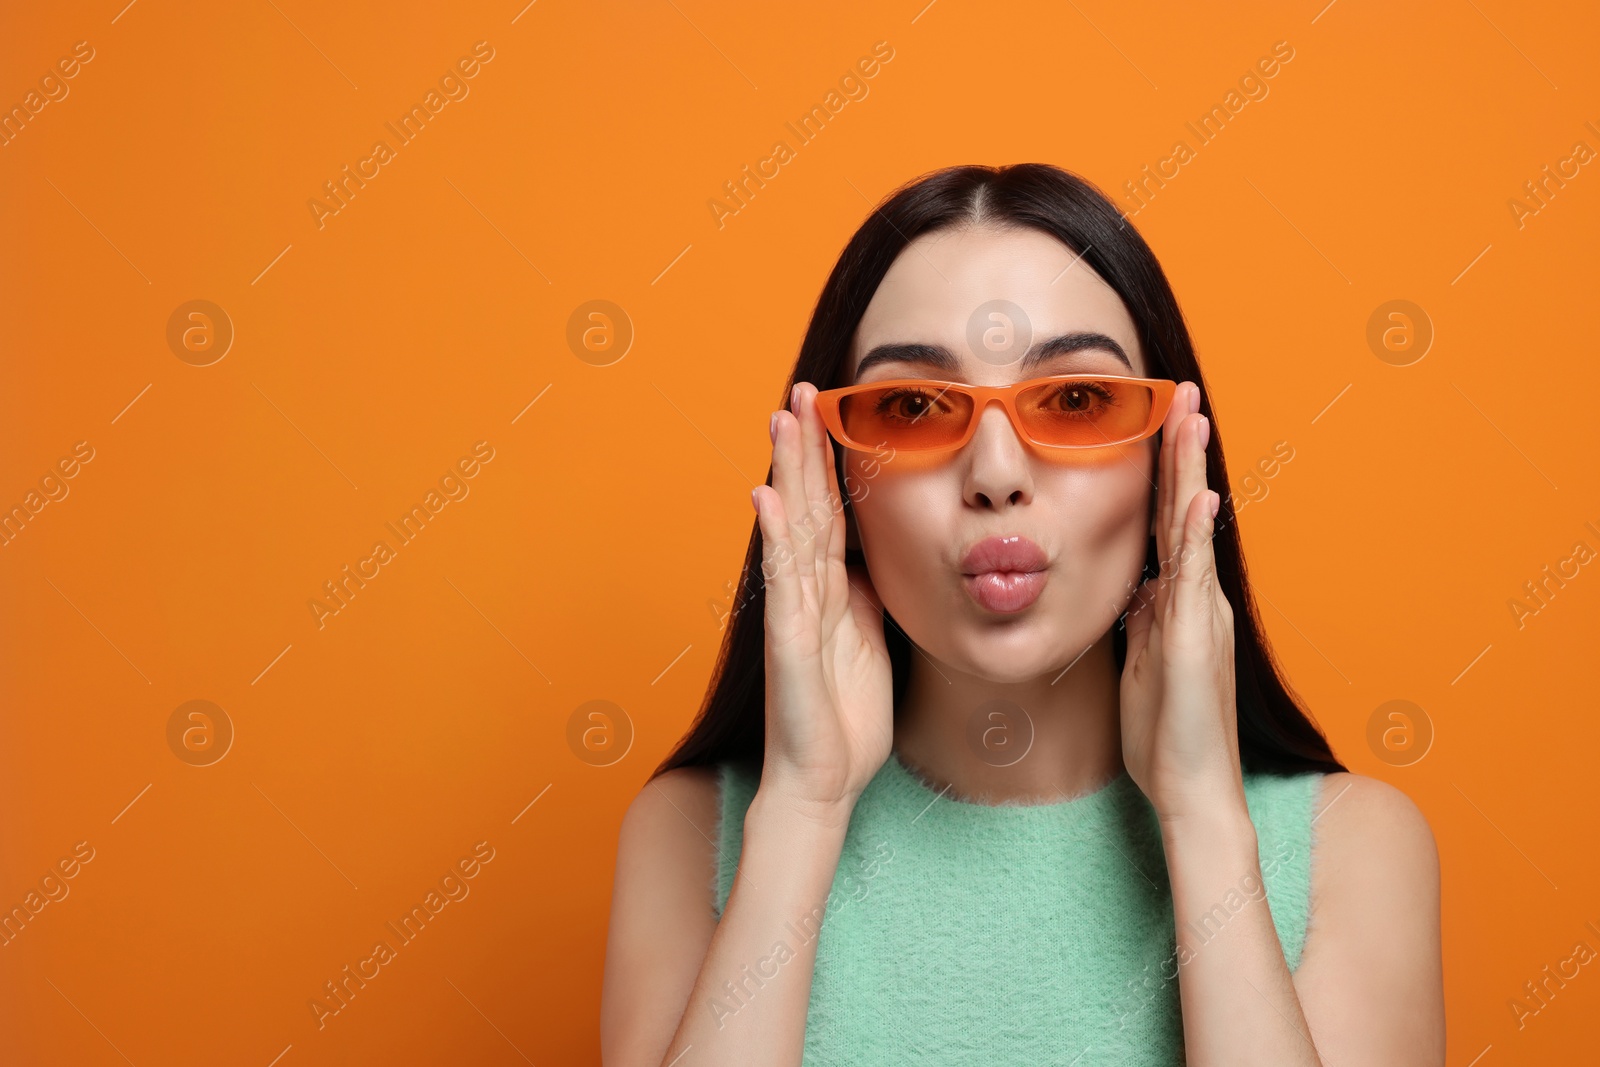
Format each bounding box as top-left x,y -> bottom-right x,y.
602,163 -> 1445,1067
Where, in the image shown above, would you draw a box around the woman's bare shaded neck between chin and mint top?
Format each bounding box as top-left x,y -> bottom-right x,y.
894,630 -> 1123,803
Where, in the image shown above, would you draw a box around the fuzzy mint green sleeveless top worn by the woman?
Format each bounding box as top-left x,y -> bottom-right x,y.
712,753 -> 1322,1067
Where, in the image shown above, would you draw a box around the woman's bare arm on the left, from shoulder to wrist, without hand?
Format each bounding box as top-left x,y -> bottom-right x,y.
602,771 -> 850,1067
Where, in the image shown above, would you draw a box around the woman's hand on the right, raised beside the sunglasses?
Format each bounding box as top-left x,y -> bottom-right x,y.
1122,382 -> 1245,821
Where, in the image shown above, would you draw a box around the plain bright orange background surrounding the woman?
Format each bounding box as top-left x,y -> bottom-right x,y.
0,0 -> 1600,1067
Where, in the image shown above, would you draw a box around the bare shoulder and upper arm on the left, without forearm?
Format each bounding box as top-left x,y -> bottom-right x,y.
600,766 -> 720,1064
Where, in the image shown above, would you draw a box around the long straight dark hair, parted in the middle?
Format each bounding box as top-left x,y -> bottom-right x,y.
651,163 -> 1346,777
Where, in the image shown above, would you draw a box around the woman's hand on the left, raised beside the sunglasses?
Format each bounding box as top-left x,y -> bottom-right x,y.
750,382 -> 894,821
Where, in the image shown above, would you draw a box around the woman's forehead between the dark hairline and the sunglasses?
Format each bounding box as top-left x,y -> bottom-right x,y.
846,227 -> 1149,384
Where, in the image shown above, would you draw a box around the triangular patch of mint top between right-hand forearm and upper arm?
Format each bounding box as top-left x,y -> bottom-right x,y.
1245,771 -> 1326,974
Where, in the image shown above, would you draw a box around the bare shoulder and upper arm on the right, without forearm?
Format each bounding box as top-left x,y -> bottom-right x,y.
1293,773 -> 1445,1065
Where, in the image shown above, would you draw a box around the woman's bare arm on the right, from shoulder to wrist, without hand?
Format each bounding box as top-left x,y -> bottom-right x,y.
1163,774 -> 1445,1067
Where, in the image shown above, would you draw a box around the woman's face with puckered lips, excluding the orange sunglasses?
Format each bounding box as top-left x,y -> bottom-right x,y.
840,227 -> 1157,681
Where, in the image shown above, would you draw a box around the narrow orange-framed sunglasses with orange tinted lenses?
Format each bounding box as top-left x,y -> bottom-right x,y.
816,374 -> 1178,451
